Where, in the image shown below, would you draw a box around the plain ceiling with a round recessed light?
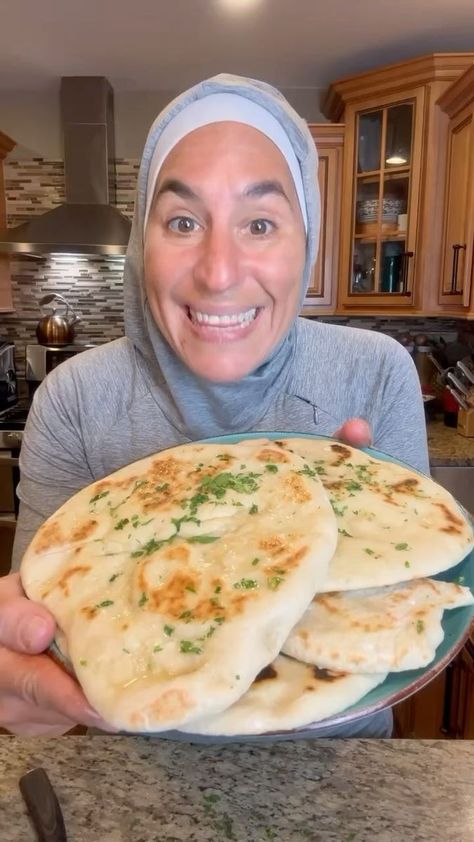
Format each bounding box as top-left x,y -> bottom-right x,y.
0,0 -> 474,92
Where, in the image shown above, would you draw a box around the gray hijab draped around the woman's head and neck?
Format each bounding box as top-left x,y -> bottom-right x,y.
124,74 -> 320,439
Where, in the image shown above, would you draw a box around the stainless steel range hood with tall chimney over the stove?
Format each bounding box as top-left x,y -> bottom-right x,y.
0,76 -> 131,256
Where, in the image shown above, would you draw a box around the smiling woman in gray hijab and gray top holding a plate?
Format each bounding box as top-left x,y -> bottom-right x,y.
0,76 -> 428,736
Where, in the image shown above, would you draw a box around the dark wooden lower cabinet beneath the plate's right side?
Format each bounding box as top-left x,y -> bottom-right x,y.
394,629 -> 474,740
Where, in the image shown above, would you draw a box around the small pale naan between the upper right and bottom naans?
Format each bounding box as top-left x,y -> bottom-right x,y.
282,579 -> 474,673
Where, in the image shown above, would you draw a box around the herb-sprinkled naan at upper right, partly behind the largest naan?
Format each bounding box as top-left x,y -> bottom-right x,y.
283,439 -> 474,592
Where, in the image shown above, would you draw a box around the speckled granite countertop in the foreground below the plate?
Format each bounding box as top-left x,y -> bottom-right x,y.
0,736 -> 474,842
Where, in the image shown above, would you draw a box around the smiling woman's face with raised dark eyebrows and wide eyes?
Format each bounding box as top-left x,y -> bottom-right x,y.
144,122 -> 305,382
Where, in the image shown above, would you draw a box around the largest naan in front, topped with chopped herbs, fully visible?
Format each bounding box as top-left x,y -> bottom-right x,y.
21,440 -> 337,732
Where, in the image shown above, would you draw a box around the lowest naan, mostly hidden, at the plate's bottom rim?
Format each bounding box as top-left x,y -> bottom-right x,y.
180,655 -> 386,736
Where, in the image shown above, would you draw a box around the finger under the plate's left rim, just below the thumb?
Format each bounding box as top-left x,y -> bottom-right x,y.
0,649 -> 113,730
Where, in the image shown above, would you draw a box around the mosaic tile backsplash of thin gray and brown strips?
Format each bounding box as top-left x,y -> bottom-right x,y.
0,158 -> 470,377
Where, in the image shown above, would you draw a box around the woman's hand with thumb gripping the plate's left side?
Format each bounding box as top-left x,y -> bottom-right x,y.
0,573 -> 111,736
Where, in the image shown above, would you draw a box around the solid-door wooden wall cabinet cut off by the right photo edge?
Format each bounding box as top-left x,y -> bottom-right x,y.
438,65 -> 474,317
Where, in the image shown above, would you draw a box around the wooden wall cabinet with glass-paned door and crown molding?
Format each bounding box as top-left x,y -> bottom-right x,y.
322,53 -> 474,315
